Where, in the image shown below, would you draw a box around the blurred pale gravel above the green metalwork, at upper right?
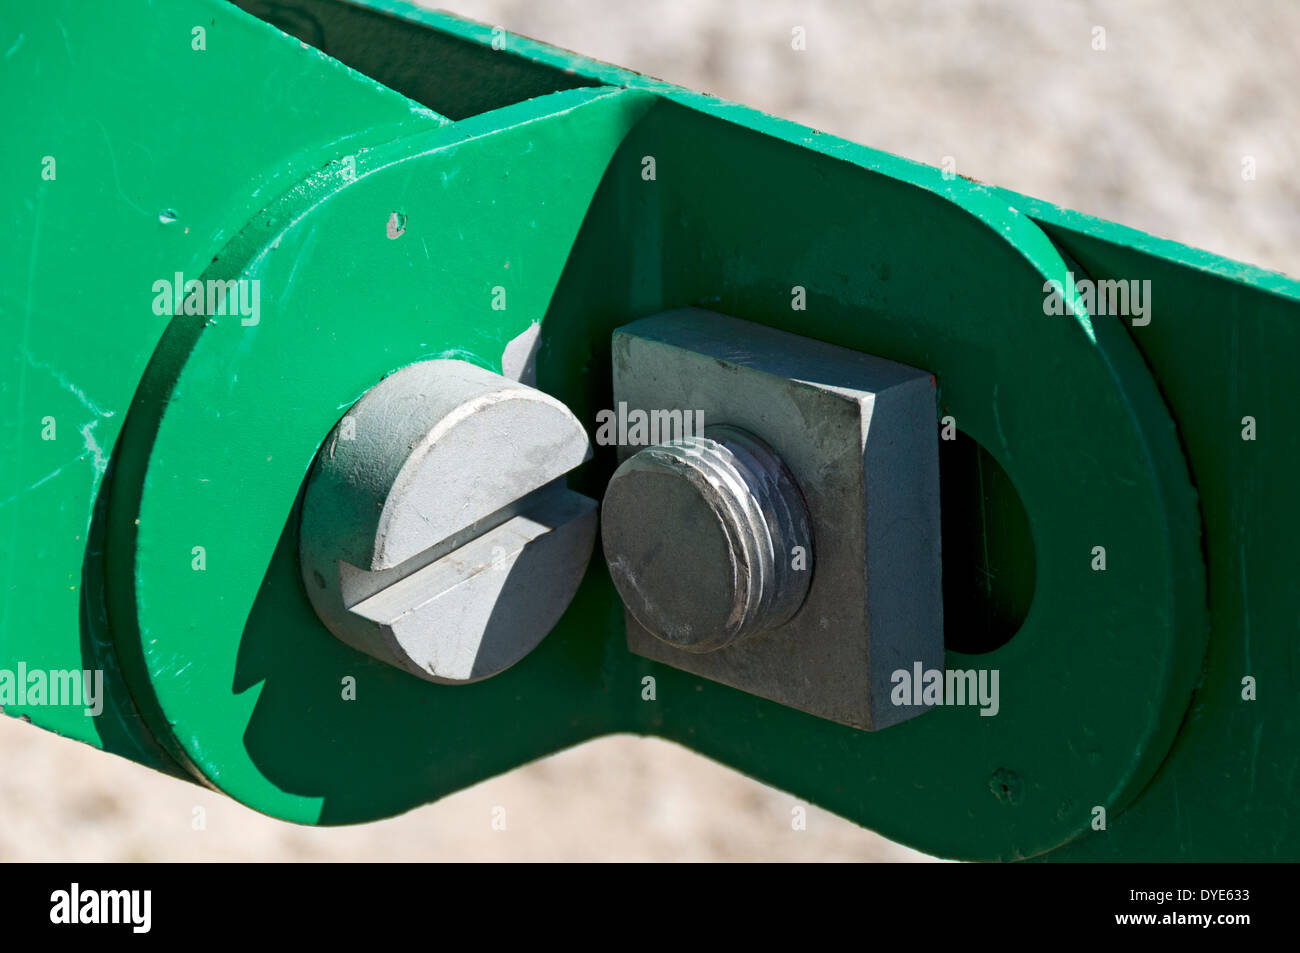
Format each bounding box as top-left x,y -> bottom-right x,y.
439,0 -> 1300,274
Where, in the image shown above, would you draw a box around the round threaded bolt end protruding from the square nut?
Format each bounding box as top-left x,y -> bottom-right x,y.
601,426 -> 813,653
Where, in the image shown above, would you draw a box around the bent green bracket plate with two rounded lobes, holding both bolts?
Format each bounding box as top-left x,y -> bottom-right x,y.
98,76 -> 1204,857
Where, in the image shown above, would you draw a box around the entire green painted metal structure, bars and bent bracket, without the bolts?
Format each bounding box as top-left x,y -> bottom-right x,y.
0,0 -> 1300,859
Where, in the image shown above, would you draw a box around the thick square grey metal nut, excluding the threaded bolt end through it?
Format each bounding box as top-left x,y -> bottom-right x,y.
602,308 -> 944,729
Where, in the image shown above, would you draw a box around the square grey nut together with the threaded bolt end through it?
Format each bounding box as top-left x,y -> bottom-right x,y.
602,308 -> 944,729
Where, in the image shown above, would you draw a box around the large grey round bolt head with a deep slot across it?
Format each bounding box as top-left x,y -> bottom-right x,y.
299,360 -> 597,684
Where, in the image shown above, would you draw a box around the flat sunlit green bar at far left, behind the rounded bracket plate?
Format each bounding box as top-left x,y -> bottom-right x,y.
0,0 -> 445,771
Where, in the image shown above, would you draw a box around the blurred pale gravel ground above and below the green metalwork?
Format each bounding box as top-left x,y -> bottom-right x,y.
0,0 -> 1300,861
